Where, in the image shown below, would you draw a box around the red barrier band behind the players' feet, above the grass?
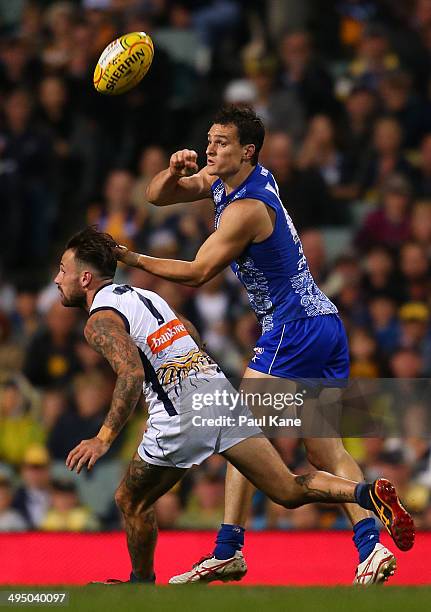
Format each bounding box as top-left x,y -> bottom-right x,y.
0,531 -> 431,585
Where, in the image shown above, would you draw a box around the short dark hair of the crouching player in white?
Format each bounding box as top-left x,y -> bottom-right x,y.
66,226 -> 117,278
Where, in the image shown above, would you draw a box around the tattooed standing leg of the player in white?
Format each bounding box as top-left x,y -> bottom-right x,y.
115,453 -> 187,582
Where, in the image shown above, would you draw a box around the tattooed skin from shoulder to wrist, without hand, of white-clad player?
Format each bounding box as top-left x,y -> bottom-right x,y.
85,315 -> 143,433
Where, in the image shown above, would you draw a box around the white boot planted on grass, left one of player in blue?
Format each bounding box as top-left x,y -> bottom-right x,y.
169,550 -> 247,584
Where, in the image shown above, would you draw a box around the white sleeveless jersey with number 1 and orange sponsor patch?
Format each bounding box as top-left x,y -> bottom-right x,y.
90,283 -> 223,416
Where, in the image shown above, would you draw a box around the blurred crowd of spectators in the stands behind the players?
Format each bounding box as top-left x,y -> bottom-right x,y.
0,0 -> 431,531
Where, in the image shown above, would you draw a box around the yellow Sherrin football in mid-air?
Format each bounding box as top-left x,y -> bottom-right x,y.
93,32 -> 154,96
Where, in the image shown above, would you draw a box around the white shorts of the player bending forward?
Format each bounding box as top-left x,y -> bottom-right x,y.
138,377 -> 263,469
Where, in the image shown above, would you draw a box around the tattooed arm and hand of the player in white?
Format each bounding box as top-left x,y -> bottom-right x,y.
66,310 -> 144,474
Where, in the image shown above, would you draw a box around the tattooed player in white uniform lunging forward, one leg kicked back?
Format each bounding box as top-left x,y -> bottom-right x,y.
55,228 -> 414,584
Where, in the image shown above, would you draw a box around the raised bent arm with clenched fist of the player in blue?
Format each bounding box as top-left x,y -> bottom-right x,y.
146,149 -> 215,206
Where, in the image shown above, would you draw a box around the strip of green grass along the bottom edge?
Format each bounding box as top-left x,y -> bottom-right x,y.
0,585 -> 431,612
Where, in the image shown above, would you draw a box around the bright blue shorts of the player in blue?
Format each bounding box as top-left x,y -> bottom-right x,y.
248,314 -> 349,386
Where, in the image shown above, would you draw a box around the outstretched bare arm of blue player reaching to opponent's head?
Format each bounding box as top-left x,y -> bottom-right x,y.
117,200 -> 266,287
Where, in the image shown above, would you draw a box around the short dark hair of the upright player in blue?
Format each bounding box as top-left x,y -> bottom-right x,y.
213,104 -> 265,166
